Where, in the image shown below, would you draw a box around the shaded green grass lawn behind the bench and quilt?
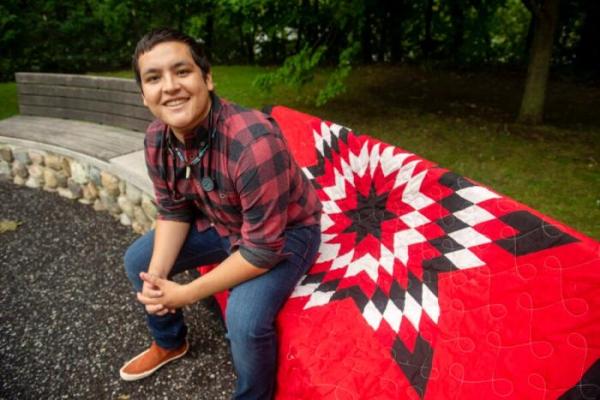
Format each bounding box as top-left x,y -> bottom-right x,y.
0,66 -> 600,238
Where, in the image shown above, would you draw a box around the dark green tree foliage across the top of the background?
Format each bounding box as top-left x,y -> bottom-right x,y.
0,0 -> 600,86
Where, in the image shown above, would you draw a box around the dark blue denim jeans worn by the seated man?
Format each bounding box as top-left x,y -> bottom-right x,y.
125,226 -> 321,400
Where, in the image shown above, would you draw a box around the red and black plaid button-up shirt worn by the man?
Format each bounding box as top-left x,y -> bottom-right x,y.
144,95 -> 321,268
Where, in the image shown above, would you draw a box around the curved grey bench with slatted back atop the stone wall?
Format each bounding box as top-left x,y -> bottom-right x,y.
0,73 -> 152,194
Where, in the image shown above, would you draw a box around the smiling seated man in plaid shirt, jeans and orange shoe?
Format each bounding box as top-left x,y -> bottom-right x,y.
120,29 -> 321,399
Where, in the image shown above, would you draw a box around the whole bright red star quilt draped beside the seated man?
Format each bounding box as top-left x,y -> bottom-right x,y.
203,107 -> 600,400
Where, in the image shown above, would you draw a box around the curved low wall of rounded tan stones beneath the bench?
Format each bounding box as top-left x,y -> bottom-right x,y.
0,144 -> 156,234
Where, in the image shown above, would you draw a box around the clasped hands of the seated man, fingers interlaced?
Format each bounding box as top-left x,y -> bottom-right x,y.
137,272 -> 193,316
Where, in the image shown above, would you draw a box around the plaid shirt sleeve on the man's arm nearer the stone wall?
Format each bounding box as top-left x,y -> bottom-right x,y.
144,135 -> 194,222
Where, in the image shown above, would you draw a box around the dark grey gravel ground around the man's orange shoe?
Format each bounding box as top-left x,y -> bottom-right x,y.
0,181 -> 235,400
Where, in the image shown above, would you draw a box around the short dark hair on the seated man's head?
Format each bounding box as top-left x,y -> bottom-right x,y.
131,28 -> 210,88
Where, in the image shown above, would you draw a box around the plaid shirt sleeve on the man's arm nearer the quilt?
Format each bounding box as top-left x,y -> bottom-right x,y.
235,134 -> 291,268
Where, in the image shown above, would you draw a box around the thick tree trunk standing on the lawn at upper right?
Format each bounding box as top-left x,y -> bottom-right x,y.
518,0 -> 560,125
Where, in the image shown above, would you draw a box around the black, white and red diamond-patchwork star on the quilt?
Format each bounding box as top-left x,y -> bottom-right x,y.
292,122 -> 575,396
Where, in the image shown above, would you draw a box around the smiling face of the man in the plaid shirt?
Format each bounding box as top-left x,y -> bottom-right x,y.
138,42 -> 214,141
